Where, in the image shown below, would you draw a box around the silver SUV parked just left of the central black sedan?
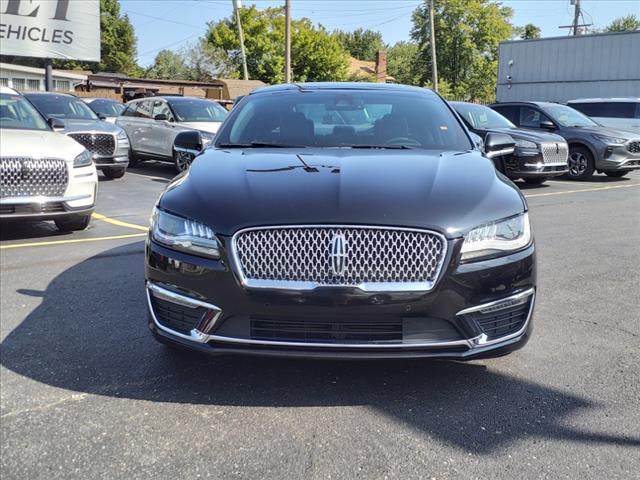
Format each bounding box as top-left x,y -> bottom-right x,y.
116,96 -> 229,172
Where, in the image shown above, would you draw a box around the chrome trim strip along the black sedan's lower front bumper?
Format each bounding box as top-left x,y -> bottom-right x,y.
146,281 -> 535,350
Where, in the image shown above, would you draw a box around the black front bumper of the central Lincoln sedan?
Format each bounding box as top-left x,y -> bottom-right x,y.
146,237 -> 536,359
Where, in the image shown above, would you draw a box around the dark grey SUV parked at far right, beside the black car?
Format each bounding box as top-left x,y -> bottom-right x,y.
491,102 -> 640,180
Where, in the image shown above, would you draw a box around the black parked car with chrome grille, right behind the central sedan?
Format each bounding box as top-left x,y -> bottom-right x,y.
449,102 -> 569,185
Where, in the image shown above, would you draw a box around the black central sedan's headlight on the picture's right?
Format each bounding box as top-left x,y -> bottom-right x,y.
461,213 -> 531,260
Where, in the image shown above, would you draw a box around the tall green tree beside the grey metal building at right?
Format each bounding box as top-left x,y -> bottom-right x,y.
411,0 -> 513,100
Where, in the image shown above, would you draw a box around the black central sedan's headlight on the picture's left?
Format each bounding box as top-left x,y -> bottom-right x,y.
151,208 -> 220,258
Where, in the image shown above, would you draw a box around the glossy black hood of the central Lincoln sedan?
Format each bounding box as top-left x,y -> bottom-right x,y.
160,149 -> 526,237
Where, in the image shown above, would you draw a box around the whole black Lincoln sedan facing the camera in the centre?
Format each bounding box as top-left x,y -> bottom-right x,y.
146,83 -> 536,359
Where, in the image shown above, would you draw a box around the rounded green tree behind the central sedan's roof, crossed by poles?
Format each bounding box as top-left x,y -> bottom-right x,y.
205,5 -> 347,83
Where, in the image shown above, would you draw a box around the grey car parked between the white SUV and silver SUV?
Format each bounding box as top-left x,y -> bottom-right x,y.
25,92 -> 129,178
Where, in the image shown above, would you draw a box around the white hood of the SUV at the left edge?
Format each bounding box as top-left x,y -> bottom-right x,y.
0,128 -> 84,161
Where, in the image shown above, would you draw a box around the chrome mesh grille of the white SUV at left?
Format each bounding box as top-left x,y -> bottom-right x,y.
0,157 -> 69,198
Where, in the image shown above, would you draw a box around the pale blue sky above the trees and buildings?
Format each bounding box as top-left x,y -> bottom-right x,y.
120,0 -> 640,67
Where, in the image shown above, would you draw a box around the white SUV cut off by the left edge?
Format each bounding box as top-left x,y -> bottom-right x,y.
0,87 -> 98,231
